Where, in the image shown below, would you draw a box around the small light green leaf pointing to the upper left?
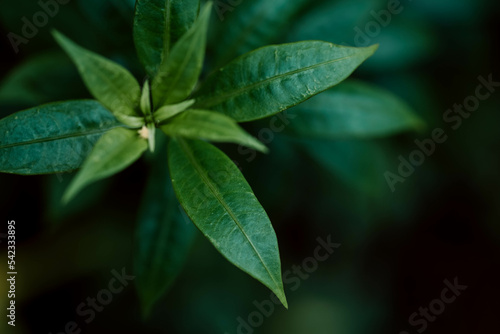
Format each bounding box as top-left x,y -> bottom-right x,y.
53,31 -> 144,127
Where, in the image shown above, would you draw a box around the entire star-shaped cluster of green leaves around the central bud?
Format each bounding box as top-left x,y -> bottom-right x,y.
0,0 -> 422,313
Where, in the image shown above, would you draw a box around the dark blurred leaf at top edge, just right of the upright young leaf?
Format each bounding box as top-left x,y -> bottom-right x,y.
212,0 -> 310,67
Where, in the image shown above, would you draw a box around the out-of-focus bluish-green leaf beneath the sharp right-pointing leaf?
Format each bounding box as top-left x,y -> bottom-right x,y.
288,80 -> 423,139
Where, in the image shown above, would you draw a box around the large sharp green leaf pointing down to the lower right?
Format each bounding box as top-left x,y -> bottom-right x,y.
169,139 -> 287,307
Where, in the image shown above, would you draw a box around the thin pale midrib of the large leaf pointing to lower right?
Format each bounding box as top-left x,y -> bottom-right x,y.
177,138 -> 279,287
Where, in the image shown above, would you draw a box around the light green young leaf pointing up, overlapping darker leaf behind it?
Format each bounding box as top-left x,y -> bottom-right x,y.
152,2 -> 212,109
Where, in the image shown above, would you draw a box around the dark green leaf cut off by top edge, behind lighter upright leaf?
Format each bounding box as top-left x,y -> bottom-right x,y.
134,0 -> 200,77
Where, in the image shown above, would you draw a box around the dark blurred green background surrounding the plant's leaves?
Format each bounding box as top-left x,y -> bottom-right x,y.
0,0 -> 500,334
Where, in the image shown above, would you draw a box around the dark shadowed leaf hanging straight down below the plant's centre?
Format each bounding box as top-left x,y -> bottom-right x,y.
134,142 -> 196,316
